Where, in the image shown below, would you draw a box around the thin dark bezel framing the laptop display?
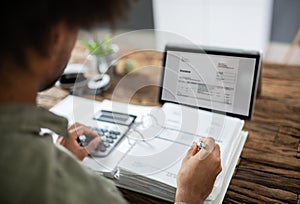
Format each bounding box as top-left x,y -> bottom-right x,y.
158,45 -> 262,120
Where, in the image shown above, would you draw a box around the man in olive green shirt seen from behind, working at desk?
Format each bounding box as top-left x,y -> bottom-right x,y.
0,0 -> 221,204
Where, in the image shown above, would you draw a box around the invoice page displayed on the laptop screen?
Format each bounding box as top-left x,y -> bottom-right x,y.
176,53 -> 239,111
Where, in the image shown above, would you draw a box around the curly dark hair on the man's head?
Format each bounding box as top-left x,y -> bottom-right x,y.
0,0 -> 130,63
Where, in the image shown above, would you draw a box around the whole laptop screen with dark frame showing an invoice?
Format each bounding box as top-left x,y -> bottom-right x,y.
160,45 -> 261,119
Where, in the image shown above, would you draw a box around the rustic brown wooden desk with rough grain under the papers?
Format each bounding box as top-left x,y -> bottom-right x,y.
38,52 -> 300,204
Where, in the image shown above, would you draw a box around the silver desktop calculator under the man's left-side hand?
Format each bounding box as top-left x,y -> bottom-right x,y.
77,110 -> 136,157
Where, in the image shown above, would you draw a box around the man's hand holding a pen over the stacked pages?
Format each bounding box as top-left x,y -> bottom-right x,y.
176,138 -> 222,204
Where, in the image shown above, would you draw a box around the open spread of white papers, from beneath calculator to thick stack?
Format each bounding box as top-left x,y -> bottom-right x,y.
51,96 -> 247,204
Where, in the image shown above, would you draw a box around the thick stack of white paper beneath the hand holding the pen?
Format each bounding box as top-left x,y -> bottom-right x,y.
113,104 -> 247,203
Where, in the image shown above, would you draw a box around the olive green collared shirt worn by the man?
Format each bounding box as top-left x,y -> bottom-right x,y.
0,105 -> 127,204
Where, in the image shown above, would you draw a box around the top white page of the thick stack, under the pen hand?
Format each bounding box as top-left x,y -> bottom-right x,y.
119,103 -> 244,199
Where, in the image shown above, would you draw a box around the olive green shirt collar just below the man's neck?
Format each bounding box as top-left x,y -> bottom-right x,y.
0,104 -> 69,137
